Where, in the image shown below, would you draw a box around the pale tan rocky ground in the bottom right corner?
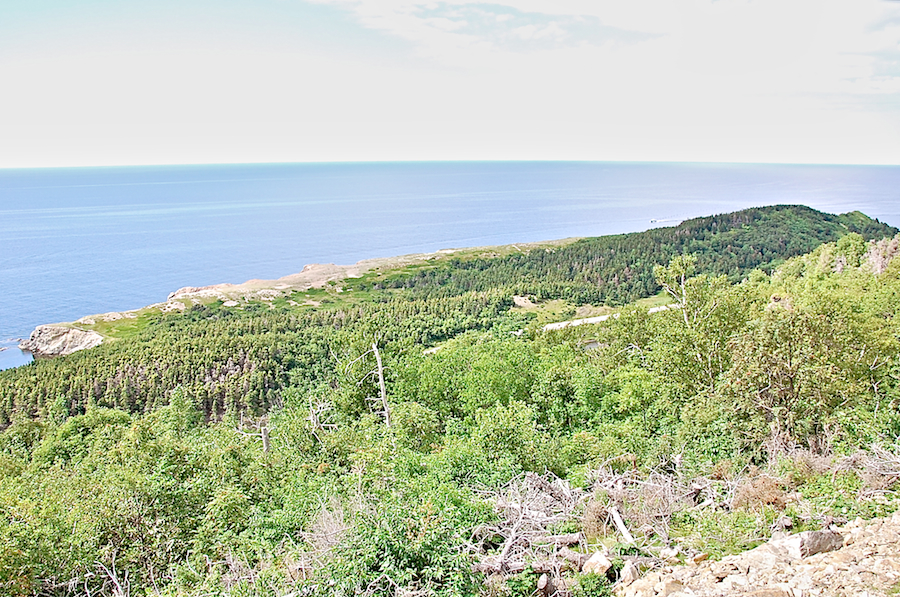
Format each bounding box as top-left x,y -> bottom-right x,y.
616,512 -> 900,597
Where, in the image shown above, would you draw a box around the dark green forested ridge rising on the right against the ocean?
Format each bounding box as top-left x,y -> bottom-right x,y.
372,205 -> 896,305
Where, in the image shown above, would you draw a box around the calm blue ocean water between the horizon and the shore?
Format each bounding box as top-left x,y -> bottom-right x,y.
0,162 -> 900,369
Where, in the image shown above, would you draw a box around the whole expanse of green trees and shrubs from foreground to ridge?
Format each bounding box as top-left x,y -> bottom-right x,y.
0,208 -> 900,596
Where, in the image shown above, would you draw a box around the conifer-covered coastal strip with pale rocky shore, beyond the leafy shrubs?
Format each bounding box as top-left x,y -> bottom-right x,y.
0,206 -> 897,425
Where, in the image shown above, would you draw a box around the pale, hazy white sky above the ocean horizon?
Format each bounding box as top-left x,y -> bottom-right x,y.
0,0 -> 900,168
